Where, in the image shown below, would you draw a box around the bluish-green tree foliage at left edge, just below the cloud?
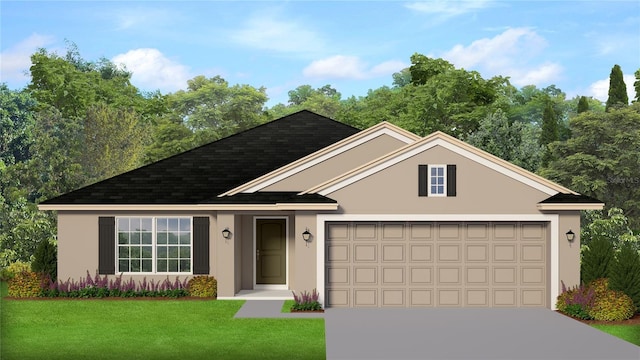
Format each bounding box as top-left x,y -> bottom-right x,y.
0,84 -> 36,164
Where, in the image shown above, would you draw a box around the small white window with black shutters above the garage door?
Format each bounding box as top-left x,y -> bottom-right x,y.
418,164 -> 456,197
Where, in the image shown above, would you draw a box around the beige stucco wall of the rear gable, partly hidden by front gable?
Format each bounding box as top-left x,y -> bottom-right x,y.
261,134 -> 406,191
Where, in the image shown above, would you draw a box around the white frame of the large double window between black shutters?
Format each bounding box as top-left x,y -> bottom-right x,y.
115,215 -> 193,275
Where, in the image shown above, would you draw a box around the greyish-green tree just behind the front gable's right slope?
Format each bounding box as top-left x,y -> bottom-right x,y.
467,109 -> 543,171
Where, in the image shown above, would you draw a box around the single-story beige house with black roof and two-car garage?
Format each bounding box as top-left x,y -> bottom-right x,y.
39,111 -> 604,309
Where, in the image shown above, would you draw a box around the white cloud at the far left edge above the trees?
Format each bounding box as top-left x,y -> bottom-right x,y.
0,34 -> 54,82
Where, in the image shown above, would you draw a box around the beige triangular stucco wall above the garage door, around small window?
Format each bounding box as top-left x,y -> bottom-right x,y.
327,146 -> 550,214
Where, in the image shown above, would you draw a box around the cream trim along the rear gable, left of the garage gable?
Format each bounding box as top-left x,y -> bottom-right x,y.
219,121 -> 420,196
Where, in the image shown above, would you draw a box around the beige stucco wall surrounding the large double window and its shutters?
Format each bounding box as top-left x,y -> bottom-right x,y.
58,211 -> 216,281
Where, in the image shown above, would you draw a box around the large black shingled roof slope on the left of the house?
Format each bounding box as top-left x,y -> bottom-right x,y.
42,110 -> 360,205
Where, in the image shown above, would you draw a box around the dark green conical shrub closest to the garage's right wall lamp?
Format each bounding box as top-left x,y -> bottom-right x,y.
580,237 -> 614,284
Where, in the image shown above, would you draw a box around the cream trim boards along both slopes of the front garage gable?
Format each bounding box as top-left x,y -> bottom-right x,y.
301,131 -> 577,196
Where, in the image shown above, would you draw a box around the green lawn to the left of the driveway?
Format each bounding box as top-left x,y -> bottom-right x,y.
0,283 -> 326,360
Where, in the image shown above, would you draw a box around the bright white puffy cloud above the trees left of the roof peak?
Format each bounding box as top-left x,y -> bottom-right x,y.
112,48 -> 191,92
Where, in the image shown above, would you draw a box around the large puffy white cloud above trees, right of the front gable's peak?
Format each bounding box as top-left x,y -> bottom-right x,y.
440,28 -> 563,86
